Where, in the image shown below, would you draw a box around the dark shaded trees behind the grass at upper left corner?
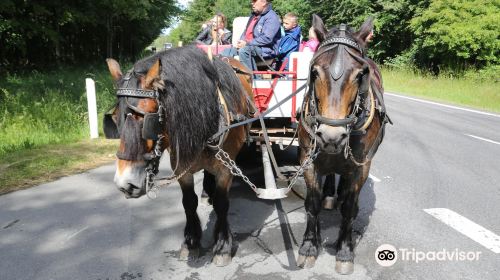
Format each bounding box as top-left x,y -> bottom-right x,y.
0,0 -> 179,70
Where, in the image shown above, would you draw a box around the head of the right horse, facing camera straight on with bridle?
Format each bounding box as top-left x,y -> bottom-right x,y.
305,15 -> 373,154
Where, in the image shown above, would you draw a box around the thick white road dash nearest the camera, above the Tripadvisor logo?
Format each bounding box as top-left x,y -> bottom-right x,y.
424,208 -> 500,254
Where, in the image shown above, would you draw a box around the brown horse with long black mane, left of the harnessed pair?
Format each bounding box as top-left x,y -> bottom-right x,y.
105,47 -> 251,265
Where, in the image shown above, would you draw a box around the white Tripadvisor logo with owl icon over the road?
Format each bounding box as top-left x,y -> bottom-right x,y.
375,244 -> 482,267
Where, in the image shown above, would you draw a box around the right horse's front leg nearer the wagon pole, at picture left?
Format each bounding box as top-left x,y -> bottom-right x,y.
297,165 -> 322,268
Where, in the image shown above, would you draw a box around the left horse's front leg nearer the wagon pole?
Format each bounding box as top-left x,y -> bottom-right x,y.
212,170 -> 233,266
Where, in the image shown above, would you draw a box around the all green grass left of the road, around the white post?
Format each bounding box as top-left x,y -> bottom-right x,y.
0,63 -> 122,194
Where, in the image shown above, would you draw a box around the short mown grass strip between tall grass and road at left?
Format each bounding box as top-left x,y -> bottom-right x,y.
0,139 -> 118,194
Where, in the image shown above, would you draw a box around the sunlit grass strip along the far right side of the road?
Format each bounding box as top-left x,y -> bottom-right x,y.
382,68 -> 500,113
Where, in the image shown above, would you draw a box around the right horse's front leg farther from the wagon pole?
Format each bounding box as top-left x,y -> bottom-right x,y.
335,163 -> 370,275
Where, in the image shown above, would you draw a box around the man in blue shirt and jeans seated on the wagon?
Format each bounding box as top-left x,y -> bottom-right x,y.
221,0 -> 281,71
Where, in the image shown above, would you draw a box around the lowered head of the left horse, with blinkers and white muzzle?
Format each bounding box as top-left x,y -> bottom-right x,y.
104,59 -> 167,198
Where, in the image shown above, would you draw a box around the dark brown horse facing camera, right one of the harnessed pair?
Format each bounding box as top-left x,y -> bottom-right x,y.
297,15 -> 388,274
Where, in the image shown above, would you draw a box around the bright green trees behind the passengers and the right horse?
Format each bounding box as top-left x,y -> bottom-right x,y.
170,0 -> 500,72
